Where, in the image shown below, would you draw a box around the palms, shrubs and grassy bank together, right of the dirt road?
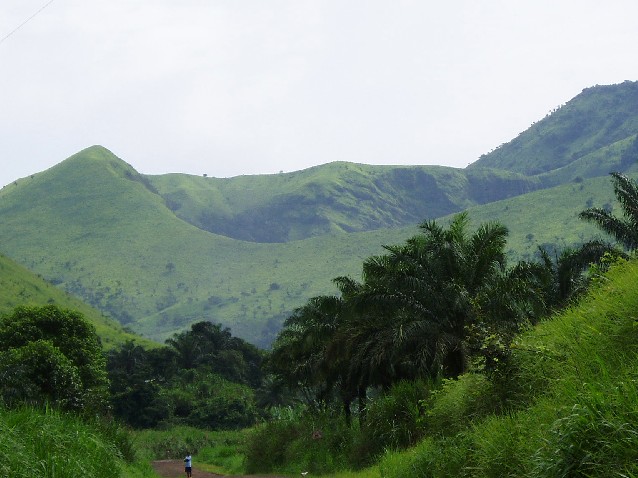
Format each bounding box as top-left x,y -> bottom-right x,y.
238,174 -> 638,477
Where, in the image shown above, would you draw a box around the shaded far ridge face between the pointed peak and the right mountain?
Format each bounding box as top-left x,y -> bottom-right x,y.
148,162 -> 540,242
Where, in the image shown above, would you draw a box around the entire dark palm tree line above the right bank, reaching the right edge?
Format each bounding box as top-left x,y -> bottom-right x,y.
269,173 -> 638,422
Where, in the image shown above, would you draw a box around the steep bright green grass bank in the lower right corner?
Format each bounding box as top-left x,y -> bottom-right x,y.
379,261 -> 638,478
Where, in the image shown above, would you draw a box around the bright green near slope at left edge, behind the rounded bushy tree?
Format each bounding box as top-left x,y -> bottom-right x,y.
0,255 -> 153,348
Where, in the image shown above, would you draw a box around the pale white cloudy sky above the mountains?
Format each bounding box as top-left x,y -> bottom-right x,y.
0,0 -> 638,185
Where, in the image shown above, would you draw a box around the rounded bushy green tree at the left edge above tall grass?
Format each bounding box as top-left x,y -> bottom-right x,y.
0,305 -> 108,411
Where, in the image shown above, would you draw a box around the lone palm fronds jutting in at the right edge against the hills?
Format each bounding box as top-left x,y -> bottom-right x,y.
579,172 -> 638,251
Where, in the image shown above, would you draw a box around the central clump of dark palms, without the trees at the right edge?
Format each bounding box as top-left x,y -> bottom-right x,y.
271,214 -> 542,426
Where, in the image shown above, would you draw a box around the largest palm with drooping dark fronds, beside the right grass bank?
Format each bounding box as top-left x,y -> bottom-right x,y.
355,213 -> 529,380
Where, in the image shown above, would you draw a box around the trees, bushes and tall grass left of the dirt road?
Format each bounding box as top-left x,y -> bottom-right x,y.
0,305 -> 262,478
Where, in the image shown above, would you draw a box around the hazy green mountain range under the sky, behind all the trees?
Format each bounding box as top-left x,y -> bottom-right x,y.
0,83 -> 638,346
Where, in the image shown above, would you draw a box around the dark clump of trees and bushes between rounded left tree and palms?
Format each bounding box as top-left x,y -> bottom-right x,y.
108,322 -> 262,429
